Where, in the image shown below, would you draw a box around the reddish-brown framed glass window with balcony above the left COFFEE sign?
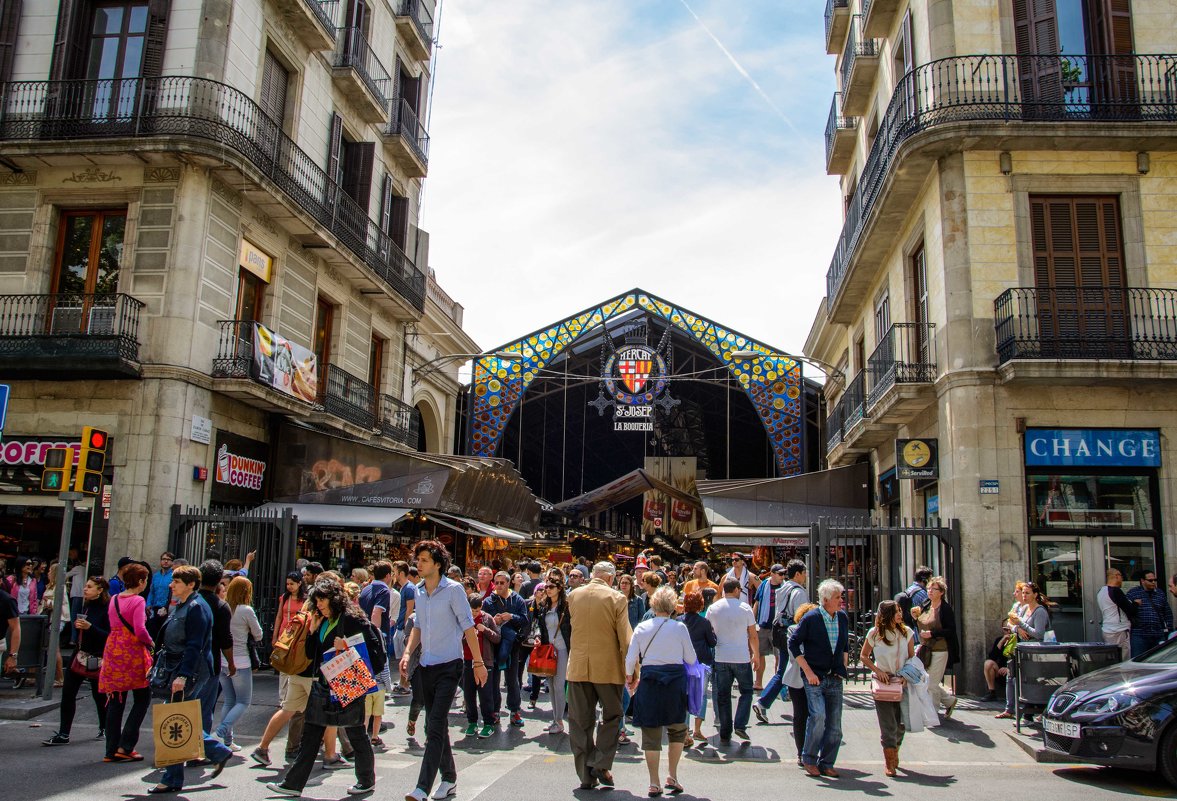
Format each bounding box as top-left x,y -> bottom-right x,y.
52,209 -> 127,295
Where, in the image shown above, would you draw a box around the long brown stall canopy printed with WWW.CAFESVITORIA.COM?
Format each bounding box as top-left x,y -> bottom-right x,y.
272,422 -> 540,539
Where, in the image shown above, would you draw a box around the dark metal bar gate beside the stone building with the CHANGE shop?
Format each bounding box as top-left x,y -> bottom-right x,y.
809,518 -> 967,675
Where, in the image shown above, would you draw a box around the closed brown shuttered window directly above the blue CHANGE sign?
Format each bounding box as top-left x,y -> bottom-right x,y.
1030,195 -> 1128,355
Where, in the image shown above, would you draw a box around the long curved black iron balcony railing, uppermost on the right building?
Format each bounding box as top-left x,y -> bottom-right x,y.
826,55 -> 1177,311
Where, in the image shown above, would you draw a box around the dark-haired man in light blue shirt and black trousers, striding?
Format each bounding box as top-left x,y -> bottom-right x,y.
400,540 -> 486,801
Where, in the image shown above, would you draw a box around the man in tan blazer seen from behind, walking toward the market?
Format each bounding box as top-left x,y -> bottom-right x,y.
568,562 -> 633,789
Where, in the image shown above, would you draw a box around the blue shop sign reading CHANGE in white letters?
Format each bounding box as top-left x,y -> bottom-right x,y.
1025,428 -> 1161,467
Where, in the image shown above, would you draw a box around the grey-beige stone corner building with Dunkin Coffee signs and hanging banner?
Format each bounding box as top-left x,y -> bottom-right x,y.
0,0 -> 477,569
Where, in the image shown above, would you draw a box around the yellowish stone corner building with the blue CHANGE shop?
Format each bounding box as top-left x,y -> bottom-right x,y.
805,0 -> 1177,687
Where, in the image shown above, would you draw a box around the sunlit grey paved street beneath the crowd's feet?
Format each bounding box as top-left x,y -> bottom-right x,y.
0,674 -> 1177,801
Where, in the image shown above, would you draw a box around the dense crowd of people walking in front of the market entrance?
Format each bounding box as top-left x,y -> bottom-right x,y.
0,541 -> 1177,801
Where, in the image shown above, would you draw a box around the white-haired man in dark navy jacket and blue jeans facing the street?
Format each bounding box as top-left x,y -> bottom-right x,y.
789,579 -> 850,779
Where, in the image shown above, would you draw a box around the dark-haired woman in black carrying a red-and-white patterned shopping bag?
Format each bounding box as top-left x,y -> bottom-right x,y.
266,579 -> 387,797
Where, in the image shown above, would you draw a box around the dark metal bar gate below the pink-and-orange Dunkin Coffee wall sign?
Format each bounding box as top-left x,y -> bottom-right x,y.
168,505 -> 298,656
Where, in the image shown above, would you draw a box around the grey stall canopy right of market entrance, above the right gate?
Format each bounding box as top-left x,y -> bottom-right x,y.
698,465 -> 870,536
